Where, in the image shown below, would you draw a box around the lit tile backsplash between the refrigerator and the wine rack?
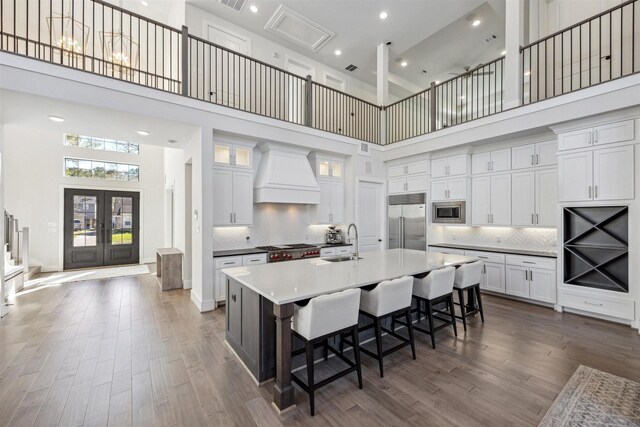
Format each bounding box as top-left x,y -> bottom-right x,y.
434,226 -> 558,252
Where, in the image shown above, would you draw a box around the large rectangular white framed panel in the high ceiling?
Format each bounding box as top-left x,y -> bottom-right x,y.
264,5 -> 336,52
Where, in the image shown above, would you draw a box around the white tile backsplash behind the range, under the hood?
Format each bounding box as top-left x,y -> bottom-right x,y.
213,203 -> 342,250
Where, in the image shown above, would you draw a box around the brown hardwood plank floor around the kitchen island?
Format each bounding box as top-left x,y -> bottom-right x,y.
0,275 -> 640,427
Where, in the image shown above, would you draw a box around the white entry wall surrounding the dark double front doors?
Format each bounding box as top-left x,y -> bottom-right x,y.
3,124 -> 164,271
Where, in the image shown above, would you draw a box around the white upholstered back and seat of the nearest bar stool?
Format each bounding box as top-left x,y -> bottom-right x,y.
291,289 -> 360,340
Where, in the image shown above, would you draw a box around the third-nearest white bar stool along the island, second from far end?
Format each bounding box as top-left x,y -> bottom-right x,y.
413,267 -> 458,349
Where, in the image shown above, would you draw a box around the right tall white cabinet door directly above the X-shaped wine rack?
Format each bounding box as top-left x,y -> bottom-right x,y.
593,145 -> 634,200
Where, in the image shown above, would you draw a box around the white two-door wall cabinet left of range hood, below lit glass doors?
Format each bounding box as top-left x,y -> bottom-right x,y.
213,168 -> 253,226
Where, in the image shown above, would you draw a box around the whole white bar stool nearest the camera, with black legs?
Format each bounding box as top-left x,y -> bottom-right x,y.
291,289 -> 362,415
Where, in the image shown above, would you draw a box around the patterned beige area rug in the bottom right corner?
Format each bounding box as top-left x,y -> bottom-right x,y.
540,365 -> 640,427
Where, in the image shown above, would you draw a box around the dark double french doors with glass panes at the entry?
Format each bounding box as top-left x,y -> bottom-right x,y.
64,188 -> 140,270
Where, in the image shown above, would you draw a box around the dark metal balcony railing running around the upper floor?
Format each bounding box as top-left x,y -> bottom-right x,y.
0,0 -> 640,144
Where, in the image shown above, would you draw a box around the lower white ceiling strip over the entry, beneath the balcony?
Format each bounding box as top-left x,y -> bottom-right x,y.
0,90 -> 198,148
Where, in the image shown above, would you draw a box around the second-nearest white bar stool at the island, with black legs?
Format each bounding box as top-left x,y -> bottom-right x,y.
345,276 -> 416,377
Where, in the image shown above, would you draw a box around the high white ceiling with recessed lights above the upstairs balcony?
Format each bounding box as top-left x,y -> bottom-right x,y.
186,0 -> 505,93
